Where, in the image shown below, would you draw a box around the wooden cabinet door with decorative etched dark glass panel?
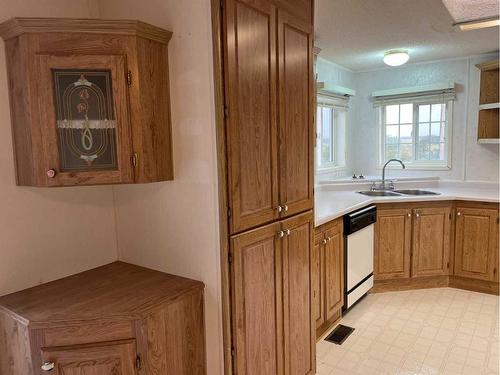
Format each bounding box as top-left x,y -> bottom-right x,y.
39,55 -> 133,185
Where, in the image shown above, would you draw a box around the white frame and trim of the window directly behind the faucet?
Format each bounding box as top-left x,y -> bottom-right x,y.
377,99 -> 454,171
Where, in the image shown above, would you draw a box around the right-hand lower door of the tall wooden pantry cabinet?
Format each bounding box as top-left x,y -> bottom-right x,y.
282,212 -> 316,375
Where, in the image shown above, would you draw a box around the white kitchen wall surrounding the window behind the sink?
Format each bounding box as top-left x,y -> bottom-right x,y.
318,54 -> 499,181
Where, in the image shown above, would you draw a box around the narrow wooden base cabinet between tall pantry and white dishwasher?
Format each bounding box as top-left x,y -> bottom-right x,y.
312,219 -> 344,336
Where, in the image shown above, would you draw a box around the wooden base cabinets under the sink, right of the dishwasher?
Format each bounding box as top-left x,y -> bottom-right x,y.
373,201 -> 499,294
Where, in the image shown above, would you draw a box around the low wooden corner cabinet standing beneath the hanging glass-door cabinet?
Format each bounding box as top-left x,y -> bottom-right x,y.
0,262 -> 206,375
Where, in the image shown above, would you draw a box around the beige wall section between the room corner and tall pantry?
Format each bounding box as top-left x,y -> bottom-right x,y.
99,0 -> 222,375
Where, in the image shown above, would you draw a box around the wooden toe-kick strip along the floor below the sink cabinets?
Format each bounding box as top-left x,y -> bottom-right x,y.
370,276 -> 499,295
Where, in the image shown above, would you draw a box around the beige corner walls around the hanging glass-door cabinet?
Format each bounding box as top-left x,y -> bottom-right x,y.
0,0 -> 223,375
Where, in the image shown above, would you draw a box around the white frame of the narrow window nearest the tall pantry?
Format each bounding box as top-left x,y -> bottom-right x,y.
314,101 -> 349,174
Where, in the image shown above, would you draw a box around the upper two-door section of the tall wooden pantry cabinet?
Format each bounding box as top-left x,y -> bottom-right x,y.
224,0 -> 314,233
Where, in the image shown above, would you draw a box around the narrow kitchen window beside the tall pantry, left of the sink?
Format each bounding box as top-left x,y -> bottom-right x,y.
315,96 -> 347,173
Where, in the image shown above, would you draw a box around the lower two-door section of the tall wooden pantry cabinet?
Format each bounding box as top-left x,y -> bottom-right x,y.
231,212 -> 316,375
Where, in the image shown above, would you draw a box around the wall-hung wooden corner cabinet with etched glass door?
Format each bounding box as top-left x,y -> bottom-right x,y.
0,18 -> 173,186
